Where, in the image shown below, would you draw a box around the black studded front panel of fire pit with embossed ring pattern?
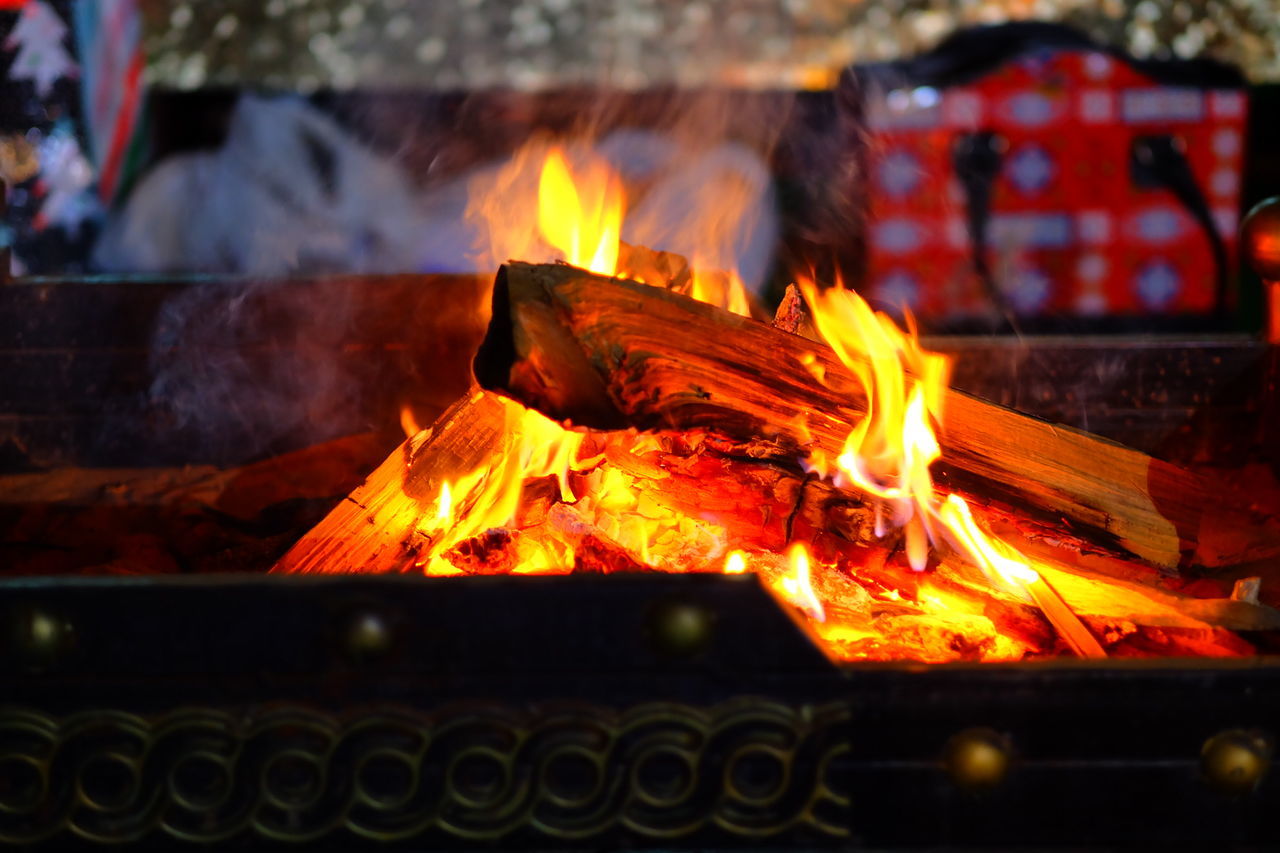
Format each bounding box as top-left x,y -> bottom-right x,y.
0,575 -> 1280,849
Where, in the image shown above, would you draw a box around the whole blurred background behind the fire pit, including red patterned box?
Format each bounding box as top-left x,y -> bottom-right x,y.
0,0 -> 1280,333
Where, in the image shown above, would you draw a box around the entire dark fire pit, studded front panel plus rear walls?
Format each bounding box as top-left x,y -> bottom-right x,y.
0,202 -> 1280,849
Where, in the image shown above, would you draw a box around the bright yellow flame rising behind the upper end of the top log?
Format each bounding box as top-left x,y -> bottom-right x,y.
538,147 -> 623,275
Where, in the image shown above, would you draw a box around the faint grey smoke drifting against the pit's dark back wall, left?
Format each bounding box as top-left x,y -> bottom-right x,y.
150,274 -> 378,464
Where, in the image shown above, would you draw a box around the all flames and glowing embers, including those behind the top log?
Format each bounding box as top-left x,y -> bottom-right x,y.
363,141 -> 1121,661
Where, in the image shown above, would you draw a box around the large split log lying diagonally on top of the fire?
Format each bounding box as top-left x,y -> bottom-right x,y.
475,263 -> 1280,571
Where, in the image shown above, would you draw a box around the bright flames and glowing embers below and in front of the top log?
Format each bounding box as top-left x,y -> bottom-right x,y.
394,266 -> 1102,661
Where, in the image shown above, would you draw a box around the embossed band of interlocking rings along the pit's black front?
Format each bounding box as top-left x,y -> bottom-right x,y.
0,698 -> 849,844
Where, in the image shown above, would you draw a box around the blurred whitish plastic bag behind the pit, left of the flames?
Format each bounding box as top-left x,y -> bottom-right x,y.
95,95 -> 422,275
